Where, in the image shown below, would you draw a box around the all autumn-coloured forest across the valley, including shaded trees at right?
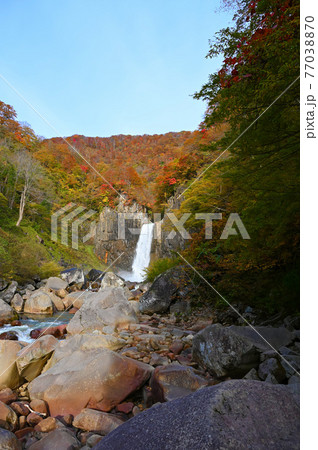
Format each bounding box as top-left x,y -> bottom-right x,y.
0,0 -> 299,309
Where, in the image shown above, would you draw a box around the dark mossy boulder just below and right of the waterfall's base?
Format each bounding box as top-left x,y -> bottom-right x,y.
139,267 -> 188,314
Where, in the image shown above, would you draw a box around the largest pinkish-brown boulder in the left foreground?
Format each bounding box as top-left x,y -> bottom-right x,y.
28,342 -> 152,416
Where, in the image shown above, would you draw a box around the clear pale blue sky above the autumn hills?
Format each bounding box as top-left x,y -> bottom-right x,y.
0,0 -> 232,137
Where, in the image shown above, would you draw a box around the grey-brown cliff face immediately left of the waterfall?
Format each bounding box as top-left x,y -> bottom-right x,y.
95,201 -> 147,270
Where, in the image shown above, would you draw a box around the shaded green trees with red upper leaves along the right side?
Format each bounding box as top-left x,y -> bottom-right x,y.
148,0 -> 299,310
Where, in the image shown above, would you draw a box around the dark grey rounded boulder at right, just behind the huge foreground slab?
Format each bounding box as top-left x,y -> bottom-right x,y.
192,324 -> 292,378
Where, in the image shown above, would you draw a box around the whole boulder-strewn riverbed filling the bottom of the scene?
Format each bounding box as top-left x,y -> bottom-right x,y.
0,271 -> 299,450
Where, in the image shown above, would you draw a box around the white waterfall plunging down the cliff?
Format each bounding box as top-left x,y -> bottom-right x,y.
118,222 -> 154,281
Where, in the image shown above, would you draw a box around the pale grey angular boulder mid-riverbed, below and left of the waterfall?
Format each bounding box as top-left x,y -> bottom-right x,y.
67,287 -> 137,334
